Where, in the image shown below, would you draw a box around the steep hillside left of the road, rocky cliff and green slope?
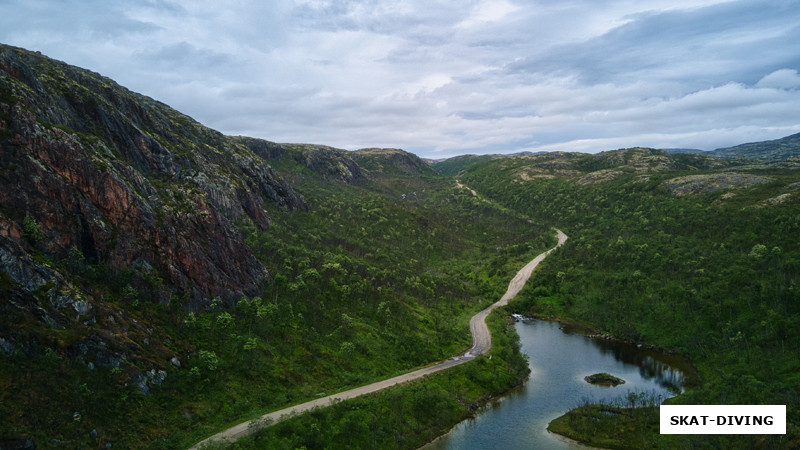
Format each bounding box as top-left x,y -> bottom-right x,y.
0,46 -> 555,448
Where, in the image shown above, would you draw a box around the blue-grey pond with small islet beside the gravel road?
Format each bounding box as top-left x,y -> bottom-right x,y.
424,320 -> 684,450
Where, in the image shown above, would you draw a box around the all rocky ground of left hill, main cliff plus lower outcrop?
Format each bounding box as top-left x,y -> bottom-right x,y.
0,42 -> 314,400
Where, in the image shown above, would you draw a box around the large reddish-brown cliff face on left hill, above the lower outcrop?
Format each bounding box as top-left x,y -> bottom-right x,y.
0,46 -> 305,301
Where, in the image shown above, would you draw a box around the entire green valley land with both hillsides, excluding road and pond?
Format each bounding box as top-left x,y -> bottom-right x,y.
0,45 -> 800,449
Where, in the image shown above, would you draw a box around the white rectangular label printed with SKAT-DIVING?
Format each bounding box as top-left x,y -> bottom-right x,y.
659,405 -> 786,434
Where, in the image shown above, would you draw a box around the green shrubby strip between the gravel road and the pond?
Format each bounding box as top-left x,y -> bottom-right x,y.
211,309 -> 529,450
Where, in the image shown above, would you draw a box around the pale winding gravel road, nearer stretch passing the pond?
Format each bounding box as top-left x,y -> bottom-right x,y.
190,230 -> 567,450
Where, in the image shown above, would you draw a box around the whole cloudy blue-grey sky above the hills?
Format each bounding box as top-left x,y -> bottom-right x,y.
0,0 -> 800,158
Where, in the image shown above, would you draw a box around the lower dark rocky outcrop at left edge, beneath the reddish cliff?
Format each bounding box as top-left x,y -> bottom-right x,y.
0,230 -> 177,394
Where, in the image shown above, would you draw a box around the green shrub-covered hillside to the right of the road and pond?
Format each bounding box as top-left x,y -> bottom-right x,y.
461,149 -> 800,448
